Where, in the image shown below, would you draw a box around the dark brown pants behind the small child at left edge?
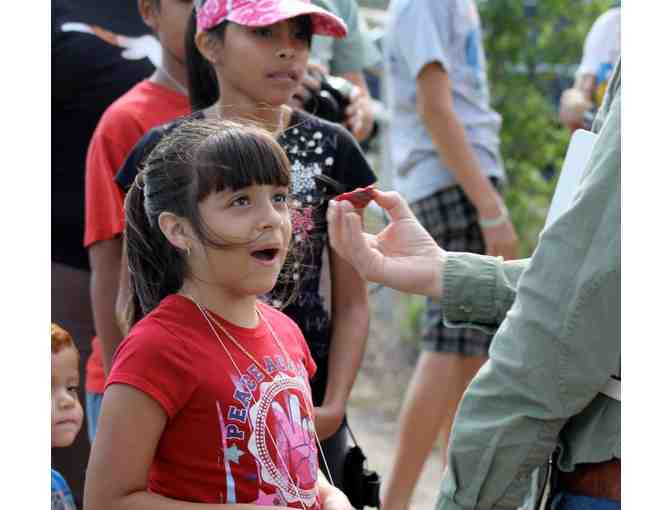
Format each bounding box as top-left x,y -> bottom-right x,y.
51,262 -> 94,508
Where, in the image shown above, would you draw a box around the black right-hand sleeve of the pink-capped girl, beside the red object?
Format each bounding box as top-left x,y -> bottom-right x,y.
333,124 -> 378,191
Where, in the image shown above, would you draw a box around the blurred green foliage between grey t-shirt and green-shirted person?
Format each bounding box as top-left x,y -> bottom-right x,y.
478,0 -> 612,256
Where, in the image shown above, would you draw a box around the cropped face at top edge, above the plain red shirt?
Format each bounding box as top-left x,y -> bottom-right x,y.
142,0 -> 194,65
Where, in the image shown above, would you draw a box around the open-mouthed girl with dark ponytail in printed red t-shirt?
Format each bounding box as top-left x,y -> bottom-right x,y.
84,120 -> 350,510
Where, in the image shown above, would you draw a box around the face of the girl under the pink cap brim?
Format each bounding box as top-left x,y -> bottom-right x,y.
214,18 -> 310,107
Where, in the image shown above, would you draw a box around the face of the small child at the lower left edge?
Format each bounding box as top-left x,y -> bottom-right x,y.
51,347 -> 84,447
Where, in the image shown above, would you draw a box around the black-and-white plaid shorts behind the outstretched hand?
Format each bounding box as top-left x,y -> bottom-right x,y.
411,183 -> 499,356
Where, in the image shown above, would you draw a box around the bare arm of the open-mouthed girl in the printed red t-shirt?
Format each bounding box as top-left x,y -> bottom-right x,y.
84,384 -> 289,510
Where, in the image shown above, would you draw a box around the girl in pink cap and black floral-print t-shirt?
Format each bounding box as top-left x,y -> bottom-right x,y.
86,0 -> 375,508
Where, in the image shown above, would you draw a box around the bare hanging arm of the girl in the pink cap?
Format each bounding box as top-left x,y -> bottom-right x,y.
315,220 -> 369,440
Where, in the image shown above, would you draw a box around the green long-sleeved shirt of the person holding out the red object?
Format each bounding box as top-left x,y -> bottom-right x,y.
436,62 -> 621,510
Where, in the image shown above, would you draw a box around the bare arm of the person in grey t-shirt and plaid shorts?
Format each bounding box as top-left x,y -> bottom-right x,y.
416,62 -> 518,259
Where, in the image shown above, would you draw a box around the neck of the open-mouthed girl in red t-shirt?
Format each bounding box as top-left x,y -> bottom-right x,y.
178,279 -> 259,328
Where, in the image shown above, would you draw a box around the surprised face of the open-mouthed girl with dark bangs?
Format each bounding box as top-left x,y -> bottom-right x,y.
188,185 -> 291,297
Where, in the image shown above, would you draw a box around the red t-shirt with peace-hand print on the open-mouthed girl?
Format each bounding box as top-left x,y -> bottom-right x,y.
106,295 -> 320,509
